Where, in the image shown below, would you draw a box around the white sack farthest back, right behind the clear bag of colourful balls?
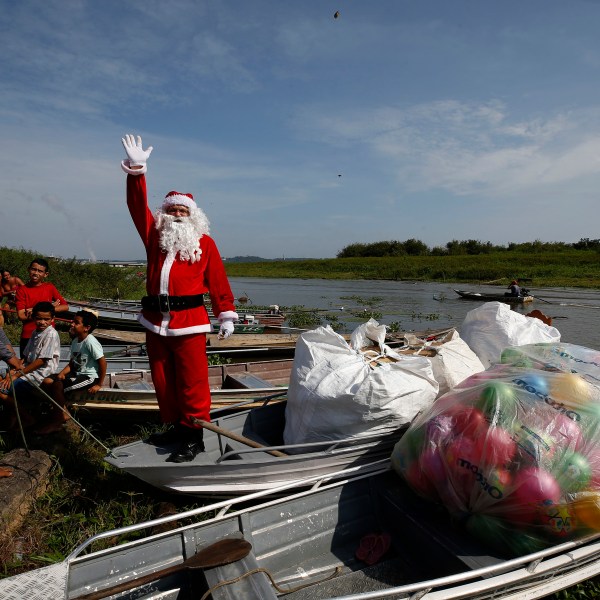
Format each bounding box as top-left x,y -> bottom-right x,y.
460,302 -> 560,369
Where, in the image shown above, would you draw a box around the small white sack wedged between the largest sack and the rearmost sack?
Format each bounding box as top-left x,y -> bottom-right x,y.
429,329 -> 485,396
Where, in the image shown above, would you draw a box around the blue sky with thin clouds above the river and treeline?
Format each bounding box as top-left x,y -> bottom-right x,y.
0,0 -> 600,259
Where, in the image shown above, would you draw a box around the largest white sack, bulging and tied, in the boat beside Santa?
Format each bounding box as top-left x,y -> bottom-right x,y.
283,326 -> 438,444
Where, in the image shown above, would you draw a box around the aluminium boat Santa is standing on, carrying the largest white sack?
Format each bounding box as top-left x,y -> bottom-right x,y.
105,402 -> 402,496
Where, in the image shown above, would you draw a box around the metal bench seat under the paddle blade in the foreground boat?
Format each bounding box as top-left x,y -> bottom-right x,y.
204,551 -> 277,600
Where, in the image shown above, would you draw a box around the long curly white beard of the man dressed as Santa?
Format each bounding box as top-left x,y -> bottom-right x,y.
155,208 -> 209,263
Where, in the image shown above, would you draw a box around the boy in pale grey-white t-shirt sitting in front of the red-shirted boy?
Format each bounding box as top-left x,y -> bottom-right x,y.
0,302 -> 60,427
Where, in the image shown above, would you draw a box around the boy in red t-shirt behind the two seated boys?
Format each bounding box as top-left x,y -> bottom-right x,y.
15,258 -> 69,357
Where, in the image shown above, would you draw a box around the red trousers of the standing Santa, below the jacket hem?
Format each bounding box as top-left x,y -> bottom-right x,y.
146,331 -> 210,427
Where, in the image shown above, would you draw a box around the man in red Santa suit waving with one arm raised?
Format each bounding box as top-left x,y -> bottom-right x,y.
121,135 -> 238,463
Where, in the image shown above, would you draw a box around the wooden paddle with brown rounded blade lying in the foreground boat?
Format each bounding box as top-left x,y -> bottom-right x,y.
73,538 -> 252,600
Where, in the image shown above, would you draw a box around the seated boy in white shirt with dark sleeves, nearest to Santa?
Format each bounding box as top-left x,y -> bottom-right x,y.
36,310 -> 106,435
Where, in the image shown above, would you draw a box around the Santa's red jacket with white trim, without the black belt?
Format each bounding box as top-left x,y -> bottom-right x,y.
127,175 -> 238,336
